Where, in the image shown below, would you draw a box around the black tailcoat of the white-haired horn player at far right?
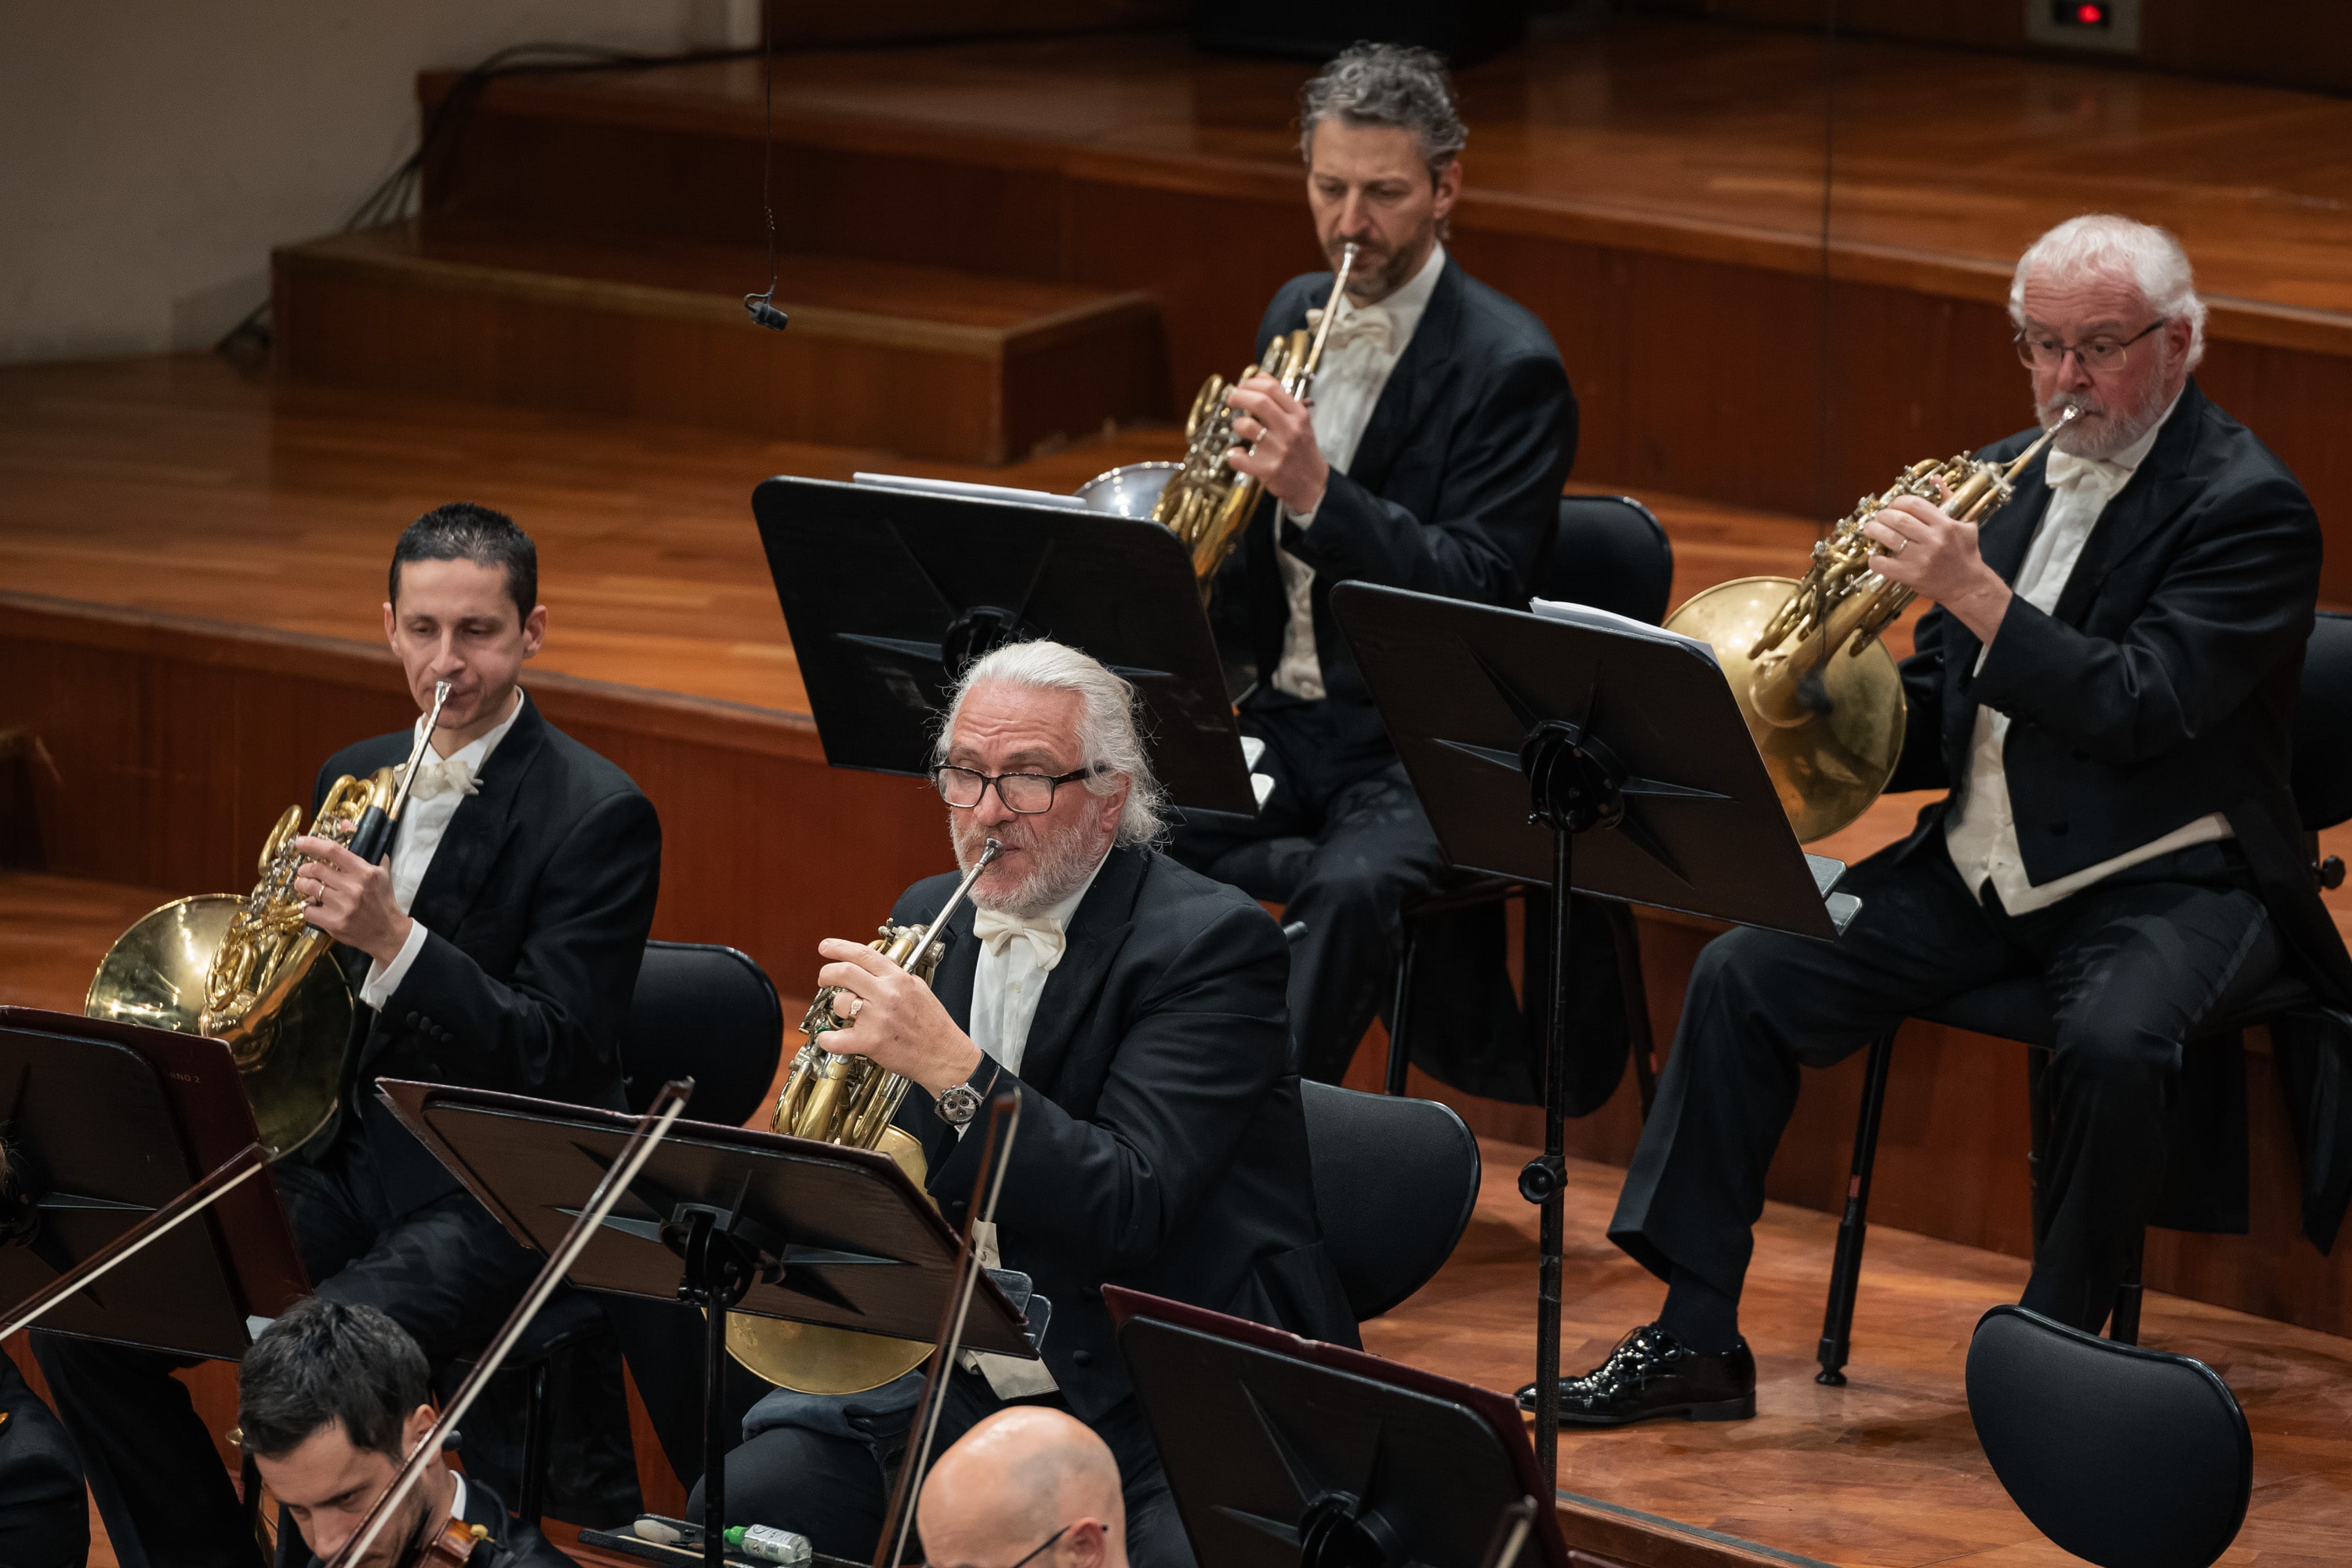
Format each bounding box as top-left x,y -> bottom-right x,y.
1889,381 -> 2352,1246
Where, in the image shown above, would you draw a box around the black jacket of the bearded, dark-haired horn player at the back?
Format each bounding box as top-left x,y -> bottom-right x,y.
1221,256 -> 1576,753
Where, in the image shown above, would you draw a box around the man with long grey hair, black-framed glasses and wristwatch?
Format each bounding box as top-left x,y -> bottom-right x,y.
689,642 -> 1355,1566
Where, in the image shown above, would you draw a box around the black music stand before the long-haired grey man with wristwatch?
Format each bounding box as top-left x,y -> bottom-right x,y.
376,1079 -> 1037,1566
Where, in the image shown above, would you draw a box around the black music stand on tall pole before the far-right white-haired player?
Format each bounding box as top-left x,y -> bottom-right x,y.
1331,583 -> 1860,1474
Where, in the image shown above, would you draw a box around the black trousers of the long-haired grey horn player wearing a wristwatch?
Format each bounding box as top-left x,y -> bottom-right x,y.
687,1370 -> 1192,1568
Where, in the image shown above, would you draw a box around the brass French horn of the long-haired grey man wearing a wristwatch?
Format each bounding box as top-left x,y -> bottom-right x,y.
727,839 -> 1004,1394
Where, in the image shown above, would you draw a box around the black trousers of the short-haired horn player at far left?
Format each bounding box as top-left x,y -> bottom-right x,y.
33,1140 -> 541,1568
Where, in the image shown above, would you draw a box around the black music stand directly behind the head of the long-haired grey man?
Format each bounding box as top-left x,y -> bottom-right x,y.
753,477 -> 1258,815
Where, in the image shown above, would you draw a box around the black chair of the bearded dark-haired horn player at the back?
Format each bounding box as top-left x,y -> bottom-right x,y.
1388,496 -> 1675,1116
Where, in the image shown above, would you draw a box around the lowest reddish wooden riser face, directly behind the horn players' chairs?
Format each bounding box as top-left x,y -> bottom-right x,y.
13,595 -> 2352,1333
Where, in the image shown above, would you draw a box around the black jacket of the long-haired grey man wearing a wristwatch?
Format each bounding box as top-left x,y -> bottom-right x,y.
891,848 -> 1357,1420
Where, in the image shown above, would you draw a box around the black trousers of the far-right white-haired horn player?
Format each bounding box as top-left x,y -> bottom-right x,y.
1609,832 -> 2279,1333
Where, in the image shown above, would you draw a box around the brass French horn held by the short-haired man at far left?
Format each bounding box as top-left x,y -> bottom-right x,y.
82,684 -> 449,1159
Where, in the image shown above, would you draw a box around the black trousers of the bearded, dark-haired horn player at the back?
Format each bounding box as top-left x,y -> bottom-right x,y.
1169,691 -> 1446,1083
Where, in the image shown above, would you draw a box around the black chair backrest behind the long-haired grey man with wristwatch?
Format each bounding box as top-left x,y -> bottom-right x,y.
1298,1079 -> 1479,1323
